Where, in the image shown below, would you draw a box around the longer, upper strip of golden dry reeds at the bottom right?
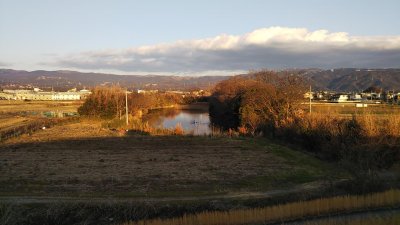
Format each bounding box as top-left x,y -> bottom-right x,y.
124,190 -> 400,225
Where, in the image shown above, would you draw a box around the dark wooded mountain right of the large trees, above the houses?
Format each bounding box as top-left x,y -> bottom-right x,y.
300,68 -> 400,91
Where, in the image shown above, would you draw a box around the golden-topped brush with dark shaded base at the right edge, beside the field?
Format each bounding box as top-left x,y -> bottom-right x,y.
276,113 -> 400,166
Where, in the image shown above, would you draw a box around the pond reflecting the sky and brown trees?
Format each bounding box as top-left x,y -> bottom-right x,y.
143,105 -> 211,135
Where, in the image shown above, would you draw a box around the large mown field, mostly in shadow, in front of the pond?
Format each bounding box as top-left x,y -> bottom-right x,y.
0,121 -> 329,197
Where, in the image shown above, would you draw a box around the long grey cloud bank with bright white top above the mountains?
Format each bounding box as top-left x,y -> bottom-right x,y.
55,27 -> 400,73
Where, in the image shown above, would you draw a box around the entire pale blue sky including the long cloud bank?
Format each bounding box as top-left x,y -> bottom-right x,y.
0,0 -> 400,75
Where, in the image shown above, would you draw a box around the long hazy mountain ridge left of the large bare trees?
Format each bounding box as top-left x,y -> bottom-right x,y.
0,69 -> 229,90
